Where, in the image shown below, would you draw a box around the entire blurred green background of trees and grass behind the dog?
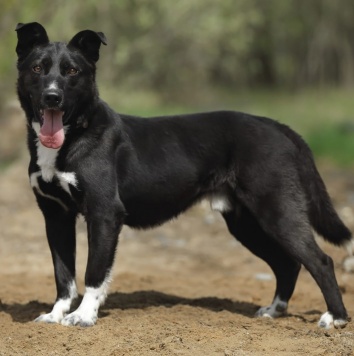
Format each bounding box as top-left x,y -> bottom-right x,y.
0,0 -> 354,167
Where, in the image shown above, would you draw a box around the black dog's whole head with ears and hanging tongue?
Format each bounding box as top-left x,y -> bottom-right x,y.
16,22 -> 107,148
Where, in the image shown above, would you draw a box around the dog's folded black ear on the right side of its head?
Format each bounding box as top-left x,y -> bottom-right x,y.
68,30 -> 107,62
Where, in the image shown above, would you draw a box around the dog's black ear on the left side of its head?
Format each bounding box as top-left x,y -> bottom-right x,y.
16,22 -> 49,59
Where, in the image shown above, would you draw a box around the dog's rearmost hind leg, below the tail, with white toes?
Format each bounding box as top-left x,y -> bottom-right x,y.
235,188 -> 349,328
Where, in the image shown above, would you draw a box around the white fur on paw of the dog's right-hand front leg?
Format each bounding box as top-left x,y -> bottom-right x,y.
61,276 -> 111,326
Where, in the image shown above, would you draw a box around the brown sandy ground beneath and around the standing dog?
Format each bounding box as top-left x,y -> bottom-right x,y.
0,156 -> 354,356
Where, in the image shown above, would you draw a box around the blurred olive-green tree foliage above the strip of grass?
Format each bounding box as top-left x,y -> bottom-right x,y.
4,0 -> 354,100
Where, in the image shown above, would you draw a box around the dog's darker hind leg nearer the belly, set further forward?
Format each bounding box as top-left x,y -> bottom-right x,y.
223,207 -> 301,318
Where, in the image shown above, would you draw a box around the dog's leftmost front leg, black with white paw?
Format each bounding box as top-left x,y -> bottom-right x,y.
35,207 -> 77,323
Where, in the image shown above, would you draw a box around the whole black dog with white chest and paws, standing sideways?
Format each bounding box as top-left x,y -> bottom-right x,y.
16,23 -> 351,328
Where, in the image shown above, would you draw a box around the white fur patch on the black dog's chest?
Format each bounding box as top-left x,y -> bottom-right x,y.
30,143 -> 78,207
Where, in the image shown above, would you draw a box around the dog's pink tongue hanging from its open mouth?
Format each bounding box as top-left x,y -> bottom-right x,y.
39,109 -> 65,148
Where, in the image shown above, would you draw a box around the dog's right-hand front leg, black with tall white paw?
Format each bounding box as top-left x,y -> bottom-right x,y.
62,209 -> 124,327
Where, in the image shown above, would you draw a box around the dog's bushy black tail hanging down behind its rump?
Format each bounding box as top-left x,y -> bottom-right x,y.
282,125 -> 354,248
